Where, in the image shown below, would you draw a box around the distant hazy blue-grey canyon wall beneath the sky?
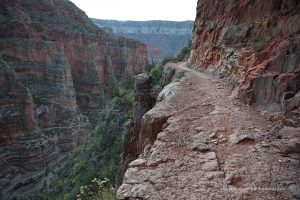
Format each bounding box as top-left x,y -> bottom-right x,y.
92,19 -> 193,63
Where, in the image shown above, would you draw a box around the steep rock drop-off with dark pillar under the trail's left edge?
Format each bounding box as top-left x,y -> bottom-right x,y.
119,64 -> 184,183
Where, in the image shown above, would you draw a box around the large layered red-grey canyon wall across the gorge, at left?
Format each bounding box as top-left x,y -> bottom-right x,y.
0,0 -> 148,199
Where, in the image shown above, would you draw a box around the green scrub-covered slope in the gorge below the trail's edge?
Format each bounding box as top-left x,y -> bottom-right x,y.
43,76 -> 132,199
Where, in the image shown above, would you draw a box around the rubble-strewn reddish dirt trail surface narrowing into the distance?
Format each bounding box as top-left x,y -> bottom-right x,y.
117,63 -> 300,200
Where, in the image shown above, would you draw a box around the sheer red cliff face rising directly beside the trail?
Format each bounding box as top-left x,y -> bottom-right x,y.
189,0 -> 300,126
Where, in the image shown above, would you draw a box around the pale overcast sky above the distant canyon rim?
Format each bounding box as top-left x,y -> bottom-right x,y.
71,0 -> 197,21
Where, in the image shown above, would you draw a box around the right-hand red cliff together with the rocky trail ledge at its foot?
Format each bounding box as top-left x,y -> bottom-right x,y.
117,0 -> 300,200
